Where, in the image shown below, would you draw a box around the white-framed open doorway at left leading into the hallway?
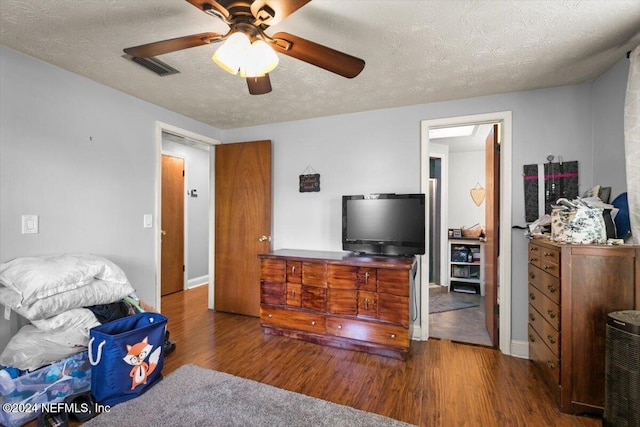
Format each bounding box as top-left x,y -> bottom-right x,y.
155,123 -> 219,310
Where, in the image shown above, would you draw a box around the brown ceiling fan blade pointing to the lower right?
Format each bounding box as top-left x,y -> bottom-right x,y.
272,33 -> 364,79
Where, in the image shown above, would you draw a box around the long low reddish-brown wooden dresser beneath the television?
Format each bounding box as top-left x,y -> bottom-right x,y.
258,249 -> 416,359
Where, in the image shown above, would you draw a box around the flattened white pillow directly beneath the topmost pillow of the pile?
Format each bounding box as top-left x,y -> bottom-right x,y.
0,280 -> 135,321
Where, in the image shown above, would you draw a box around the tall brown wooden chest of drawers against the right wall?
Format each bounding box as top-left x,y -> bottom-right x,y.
529,239 -> 640,415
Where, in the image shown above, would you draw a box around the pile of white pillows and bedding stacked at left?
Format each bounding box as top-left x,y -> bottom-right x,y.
0,253 -> 134,370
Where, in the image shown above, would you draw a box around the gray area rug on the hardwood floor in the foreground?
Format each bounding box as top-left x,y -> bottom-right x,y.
83,365 -> 410,427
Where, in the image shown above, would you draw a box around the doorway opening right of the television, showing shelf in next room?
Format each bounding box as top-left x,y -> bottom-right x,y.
428,123 -> 495,347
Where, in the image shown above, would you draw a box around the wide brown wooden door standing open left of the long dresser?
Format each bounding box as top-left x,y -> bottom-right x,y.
214,141 -> 271,316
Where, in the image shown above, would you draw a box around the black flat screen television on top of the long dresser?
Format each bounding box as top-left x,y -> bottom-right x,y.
342,194 -> 425,256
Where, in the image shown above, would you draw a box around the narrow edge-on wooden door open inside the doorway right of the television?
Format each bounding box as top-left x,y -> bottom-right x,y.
484,125 -> 500,347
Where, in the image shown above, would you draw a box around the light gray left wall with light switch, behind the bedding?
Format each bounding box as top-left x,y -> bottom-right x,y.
0,47 -> 221,348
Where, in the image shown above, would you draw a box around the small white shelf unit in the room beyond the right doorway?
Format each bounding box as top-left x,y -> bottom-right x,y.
449,238 -> 484,295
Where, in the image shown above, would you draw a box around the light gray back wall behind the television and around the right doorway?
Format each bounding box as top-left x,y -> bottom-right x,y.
223,64 -> 626,341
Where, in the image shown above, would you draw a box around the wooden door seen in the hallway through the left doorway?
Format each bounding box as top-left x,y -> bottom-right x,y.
160,154 -> 184,296
